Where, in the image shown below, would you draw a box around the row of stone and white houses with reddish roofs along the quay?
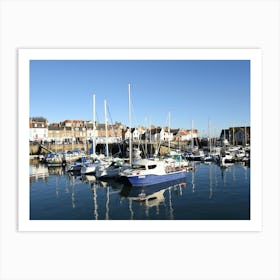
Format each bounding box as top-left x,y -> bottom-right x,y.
29,118 -> 198,143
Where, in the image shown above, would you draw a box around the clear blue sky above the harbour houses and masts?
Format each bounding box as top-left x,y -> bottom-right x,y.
30,60 -> 250,136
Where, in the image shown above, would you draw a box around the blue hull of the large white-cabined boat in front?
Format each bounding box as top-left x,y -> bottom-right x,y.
127,170 -> 187,187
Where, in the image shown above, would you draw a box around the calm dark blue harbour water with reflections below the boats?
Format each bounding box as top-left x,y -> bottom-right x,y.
30,163 -> 250,220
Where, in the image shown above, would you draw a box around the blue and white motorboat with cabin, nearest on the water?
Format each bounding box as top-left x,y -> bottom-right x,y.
122,159 -> 186,187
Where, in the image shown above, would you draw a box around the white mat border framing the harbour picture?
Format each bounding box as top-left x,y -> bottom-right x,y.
18,49 -> 262,231
